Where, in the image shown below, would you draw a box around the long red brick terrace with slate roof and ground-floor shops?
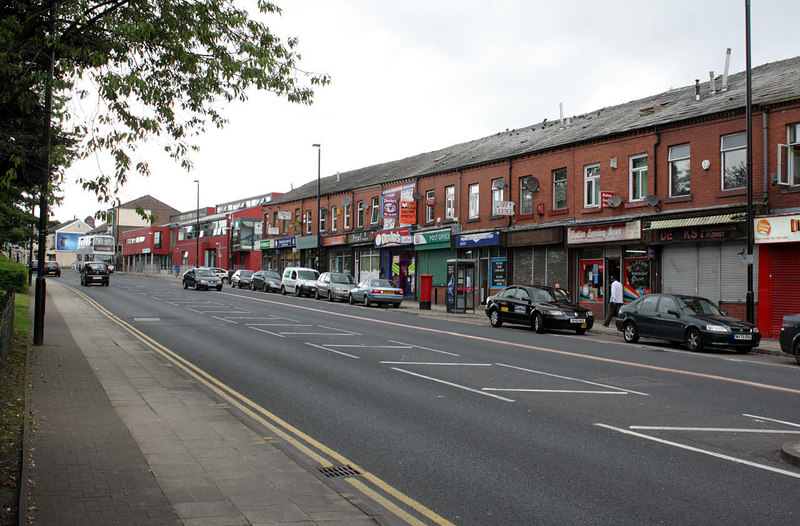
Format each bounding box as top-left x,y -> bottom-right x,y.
262,58 -> 800,332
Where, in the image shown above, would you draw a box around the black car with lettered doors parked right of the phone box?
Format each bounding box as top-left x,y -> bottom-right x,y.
486,285 -> 594,334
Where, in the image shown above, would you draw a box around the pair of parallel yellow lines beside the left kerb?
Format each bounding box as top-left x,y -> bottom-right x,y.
72,285 -> 453,526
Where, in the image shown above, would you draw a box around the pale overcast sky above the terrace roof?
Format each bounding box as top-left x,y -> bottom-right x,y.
54,0 -> 800,225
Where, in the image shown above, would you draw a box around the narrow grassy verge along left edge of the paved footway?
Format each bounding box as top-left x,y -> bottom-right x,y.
0,293 -> 31,526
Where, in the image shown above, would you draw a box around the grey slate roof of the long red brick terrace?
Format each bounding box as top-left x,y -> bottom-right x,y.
272,57 -> 800,204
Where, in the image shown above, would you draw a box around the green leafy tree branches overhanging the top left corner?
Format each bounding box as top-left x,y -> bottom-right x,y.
0,0 -> 330,212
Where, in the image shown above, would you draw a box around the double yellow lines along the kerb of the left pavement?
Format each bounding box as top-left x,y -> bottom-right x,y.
65,285 -> 453,526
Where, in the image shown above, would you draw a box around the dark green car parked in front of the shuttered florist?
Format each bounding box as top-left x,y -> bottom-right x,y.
616,294 -> 761,354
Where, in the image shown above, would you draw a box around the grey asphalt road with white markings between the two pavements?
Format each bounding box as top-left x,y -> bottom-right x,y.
61,273 -> 800,524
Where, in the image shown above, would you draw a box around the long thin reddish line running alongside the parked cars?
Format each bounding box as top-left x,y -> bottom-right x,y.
223,292 -> 800,396
